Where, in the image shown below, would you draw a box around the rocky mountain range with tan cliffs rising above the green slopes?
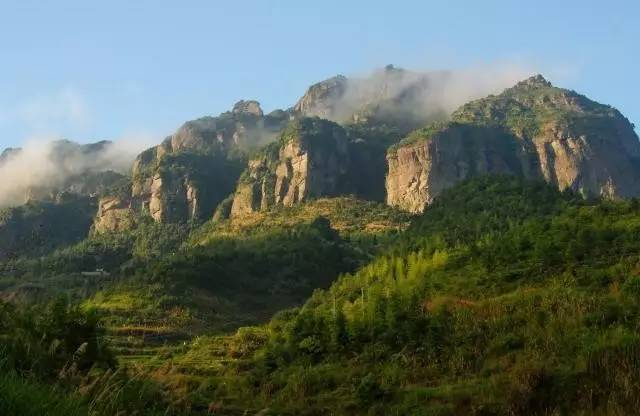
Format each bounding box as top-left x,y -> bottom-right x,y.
5,72 -> 640,255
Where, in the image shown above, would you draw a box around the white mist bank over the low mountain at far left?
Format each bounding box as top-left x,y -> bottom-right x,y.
0,137 -> 151,208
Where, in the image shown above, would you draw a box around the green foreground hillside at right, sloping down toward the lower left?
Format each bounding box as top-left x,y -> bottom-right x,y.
160,179 -> 640,415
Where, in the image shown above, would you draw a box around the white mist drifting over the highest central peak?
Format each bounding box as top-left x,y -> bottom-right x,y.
298,64 -> 534,123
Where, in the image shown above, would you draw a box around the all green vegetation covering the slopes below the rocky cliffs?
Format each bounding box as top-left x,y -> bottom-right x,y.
0,177 -> 640,415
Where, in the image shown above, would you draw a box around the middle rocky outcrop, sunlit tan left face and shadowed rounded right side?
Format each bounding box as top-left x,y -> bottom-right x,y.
231,118 -> 350,216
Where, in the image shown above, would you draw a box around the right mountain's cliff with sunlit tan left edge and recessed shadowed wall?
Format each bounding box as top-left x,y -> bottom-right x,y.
386,123 -> 537,212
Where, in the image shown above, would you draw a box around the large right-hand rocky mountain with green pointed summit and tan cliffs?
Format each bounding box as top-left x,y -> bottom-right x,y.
386,76 -> 640,212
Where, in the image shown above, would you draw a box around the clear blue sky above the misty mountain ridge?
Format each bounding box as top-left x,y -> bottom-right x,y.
0,0 -> 640,148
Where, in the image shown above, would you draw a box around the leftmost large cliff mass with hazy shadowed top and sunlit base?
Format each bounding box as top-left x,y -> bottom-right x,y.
100,101 -> 289,231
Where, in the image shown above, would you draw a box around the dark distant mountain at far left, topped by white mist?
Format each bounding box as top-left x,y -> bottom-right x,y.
0,140 -> 131,261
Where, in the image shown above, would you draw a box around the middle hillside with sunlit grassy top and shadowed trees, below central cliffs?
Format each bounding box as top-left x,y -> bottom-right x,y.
84,198 -> 409,366
